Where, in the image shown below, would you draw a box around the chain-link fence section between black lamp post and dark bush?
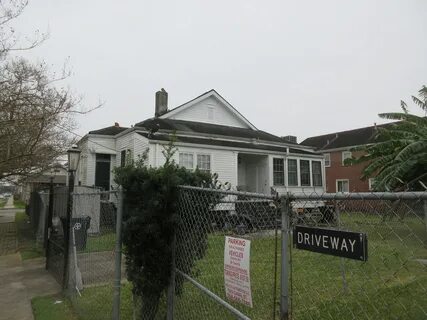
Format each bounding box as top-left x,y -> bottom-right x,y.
68,188 -> 132,320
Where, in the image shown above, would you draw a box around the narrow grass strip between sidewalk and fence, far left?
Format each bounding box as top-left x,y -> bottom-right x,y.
15,212 -> 43,260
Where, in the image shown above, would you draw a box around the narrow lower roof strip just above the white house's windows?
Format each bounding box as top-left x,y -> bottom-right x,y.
138,132 -> 318,155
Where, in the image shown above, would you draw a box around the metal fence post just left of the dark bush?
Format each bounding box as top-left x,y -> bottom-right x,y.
113,188 -> 123,320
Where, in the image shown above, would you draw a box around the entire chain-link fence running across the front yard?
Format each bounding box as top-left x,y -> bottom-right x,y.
27,186 -> 427,320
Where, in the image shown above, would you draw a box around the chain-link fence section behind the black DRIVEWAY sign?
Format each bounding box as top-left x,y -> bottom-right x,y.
289,193 -> 427,320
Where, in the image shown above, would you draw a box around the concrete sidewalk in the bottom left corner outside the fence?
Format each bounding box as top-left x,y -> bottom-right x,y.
0,253 -> 61,320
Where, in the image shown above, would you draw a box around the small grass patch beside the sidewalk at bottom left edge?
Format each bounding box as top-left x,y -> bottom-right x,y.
31,295 -> 78,320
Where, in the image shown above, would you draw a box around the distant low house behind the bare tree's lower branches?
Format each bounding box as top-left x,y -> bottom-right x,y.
20,164 -> 67,202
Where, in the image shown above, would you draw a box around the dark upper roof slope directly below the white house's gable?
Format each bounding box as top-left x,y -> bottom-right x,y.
135,118 -> 298,145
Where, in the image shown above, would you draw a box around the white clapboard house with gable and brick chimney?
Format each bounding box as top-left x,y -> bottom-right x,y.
77,89 -> 324,194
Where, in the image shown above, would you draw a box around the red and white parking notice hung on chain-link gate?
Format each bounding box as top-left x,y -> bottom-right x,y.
224,237 -> 252,307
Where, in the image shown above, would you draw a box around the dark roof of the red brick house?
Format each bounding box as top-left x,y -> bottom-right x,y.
301,123 -> 394,150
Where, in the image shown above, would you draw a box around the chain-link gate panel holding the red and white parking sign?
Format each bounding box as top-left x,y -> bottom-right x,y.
168,187 -> 280,319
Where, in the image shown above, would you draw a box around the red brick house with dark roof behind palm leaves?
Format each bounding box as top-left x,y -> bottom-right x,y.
301,124 -> 388,192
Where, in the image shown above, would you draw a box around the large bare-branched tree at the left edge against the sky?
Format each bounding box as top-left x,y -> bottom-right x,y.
0,0 -> 100,180
